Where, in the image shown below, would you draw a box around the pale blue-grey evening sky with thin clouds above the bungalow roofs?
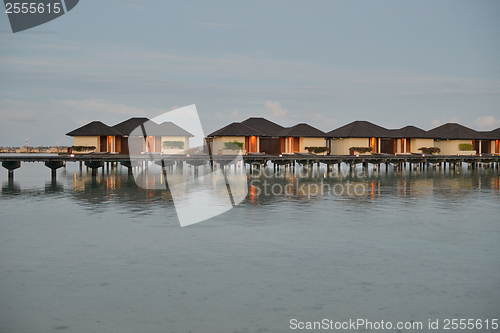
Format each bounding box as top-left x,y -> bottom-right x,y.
0,0 -> 500,147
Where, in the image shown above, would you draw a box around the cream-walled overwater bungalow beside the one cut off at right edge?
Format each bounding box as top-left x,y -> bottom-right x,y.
428,123 -> 489,155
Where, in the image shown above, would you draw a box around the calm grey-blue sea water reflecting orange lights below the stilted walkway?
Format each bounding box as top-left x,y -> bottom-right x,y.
0,163 -> 500,333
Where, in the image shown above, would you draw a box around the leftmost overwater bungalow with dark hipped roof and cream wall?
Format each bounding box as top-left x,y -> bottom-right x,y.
66,121 -> 122,153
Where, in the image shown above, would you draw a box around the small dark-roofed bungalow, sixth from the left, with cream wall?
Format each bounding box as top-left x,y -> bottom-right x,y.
278,123 -> 327,153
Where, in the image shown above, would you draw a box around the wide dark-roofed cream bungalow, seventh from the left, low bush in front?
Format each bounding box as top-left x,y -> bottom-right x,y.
326,120 -> 394,155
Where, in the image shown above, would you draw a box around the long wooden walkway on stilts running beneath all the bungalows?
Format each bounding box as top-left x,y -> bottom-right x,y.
0,154 -> 500,176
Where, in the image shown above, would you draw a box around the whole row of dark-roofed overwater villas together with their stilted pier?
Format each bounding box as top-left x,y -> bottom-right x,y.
0,117 -> 500,179
